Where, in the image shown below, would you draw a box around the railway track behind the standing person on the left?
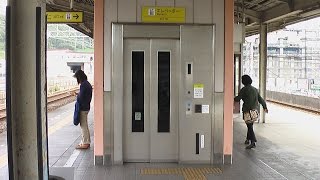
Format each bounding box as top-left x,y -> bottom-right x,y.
0,87 -> 79,121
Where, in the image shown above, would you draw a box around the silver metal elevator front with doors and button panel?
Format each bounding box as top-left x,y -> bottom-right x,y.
107,24 -> 223,164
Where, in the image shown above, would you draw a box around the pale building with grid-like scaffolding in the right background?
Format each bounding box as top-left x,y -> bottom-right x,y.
243,24 -> 320,97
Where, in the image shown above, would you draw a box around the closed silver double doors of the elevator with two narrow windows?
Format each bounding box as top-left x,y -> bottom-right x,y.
123,39 -> 180,162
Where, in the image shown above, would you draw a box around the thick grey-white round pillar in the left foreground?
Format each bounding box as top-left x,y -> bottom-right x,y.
6,0 -> 49,180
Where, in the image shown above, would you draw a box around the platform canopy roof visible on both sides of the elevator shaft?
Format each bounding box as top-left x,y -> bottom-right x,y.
47,0 -> 320,37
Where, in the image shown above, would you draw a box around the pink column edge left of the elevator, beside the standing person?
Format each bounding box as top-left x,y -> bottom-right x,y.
93,0 -> 104,156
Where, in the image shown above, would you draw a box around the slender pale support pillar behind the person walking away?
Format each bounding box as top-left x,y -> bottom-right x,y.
259,24 -> 268,123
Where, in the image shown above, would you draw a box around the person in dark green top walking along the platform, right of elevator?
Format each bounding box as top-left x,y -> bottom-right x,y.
234,75 -> 268,149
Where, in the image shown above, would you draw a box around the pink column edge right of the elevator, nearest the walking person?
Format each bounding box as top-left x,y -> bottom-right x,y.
223,0 -> 234,155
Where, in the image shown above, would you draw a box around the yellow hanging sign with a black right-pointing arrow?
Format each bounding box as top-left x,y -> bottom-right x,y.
47,12 -> 83,24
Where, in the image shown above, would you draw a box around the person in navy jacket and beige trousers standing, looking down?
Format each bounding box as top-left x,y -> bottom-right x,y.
74,70 -> 92,149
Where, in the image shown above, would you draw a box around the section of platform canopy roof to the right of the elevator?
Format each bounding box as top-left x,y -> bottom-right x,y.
238,0 -> 320,36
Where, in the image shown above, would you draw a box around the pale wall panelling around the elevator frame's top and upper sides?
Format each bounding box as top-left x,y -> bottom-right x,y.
104,0 -> 224,92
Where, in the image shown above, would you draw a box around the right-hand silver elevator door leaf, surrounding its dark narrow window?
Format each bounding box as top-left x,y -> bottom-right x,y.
150,39 -> 180,162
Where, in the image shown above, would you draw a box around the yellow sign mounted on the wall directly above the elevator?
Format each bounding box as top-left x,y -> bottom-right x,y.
141,6 -> 186,23
